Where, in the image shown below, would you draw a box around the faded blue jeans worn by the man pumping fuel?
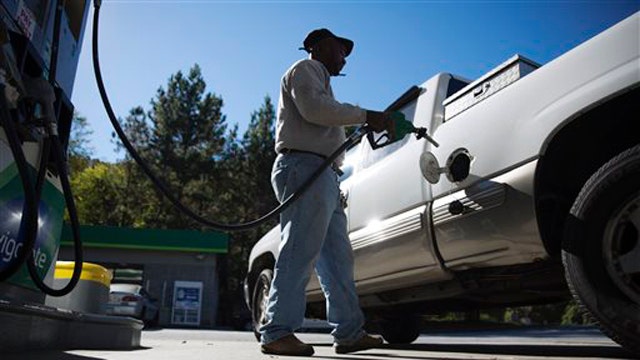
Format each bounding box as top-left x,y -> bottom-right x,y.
260,153 -> 364,344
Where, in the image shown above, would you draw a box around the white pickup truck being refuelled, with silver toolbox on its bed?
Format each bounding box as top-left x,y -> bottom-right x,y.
245,13 -> 640,352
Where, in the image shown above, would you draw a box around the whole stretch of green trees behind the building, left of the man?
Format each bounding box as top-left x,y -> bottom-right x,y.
70,65 -> 278,321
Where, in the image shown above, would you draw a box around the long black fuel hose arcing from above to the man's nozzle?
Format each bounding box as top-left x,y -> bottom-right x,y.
92,0 -> 369,231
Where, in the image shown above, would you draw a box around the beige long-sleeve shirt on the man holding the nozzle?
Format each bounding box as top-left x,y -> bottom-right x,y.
275,59 -> 366,165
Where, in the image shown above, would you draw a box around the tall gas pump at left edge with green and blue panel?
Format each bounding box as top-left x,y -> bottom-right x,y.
0,0 -> 90,303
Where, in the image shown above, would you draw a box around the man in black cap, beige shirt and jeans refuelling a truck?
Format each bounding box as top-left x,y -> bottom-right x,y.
260,29 -> 393,356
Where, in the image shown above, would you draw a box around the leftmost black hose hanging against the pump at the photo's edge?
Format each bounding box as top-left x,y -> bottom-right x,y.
0,84 -> 38,281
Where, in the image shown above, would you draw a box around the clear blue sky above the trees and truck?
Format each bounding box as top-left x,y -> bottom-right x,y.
72,0 -> 640,162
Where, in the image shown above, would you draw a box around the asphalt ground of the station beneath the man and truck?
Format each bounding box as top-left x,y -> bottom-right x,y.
0,327 -> 640,360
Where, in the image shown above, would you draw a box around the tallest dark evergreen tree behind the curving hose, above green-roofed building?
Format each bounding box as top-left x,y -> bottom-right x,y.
119,64 -> 229,228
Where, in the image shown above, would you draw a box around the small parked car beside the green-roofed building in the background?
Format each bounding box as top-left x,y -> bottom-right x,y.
107,283 -> 159,327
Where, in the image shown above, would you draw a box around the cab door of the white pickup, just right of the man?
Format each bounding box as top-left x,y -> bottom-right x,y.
346,86 -> 444,293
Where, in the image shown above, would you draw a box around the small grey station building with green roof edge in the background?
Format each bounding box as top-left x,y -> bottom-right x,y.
58,225 -> 229,328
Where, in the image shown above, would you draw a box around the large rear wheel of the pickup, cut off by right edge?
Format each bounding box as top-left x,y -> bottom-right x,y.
562,145 -> 640,353
